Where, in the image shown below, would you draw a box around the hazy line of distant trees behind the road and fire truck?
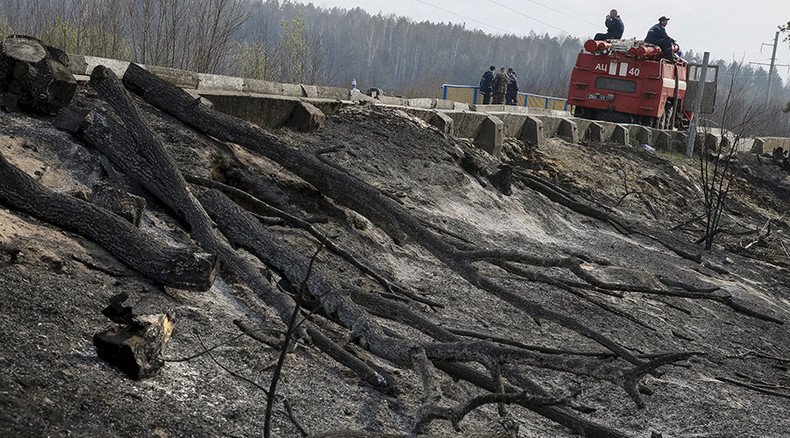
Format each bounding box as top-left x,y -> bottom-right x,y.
0,0 -> 790,136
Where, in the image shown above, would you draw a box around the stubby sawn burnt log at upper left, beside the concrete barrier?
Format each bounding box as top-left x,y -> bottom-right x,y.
0,35 -> 77,115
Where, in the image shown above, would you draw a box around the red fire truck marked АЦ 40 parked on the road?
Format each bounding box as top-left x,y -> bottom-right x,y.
568,40 -> 717,129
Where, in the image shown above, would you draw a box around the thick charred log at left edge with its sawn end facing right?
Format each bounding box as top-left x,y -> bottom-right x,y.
0,149 -> 216,290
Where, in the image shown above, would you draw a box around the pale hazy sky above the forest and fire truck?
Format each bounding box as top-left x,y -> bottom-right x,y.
299,0 -> 790,78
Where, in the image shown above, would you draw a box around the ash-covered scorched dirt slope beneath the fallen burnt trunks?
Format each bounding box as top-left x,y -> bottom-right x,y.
0,89 -> 790,437
